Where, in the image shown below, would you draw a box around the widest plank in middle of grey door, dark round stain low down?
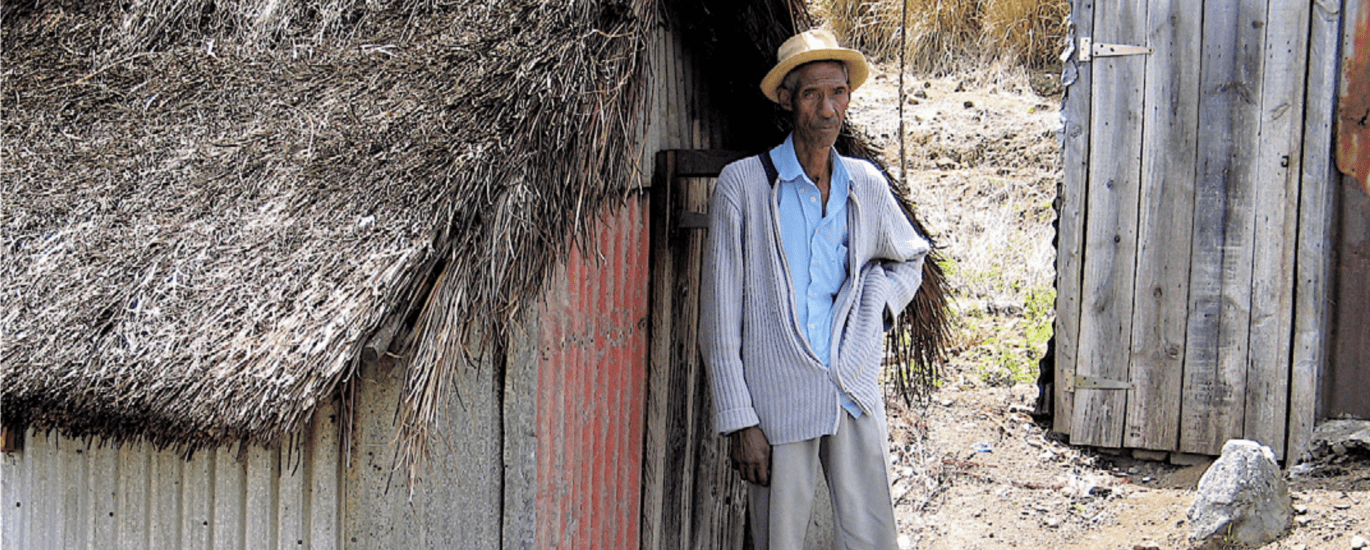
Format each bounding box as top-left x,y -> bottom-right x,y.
1180,0 -> 1266,454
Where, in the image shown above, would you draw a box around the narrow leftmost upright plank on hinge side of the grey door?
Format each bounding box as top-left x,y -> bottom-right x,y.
1052,0 -> 1095,433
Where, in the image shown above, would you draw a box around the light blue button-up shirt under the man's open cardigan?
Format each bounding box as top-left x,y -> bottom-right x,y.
770,136 -> 860,417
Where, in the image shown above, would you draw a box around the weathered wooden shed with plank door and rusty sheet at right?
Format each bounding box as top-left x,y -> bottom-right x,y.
1054,0 -> 1370,461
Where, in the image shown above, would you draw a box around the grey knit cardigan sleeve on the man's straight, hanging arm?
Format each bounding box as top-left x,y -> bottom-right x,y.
699,169 -> 760,433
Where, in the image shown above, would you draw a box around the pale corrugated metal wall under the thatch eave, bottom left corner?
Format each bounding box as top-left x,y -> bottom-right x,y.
0,397 -> 338,550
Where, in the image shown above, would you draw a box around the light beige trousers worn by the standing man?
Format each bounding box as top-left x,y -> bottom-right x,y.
748,413 -> 897,550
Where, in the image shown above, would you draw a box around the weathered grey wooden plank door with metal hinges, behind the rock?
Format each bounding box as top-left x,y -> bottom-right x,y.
1058,0 -> 1310,455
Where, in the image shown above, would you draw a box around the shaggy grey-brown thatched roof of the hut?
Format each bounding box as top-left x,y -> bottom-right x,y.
0,0 -> 947,466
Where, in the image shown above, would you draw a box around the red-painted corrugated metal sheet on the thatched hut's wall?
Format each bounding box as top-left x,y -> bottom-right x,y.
537,193 -> 651,549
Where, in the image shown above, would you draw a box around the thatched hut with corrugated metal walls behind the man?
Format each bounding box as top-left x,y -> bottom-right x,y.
0,0 -> 945,549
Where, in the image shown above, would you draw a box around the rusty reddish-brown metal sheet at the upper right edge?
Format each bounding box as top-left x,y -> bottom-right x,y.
1337,0 -> 1370,192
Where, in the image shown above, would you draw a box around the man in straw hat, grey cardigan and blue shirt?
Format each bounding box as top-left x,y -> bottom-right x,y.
700,30 -> 929,549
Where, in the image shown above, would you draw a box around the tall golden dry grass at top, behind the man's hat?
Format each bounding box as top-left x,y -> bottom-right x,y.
811,0 -> 1070,74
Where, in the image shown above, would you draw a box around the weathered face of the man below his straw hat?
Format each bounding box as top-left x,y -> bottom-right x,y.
777,62 -> 851,148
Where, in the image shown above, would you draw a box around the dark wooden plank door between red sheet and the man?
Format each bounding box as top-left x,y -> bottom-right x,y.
641,151 -> 747,550
